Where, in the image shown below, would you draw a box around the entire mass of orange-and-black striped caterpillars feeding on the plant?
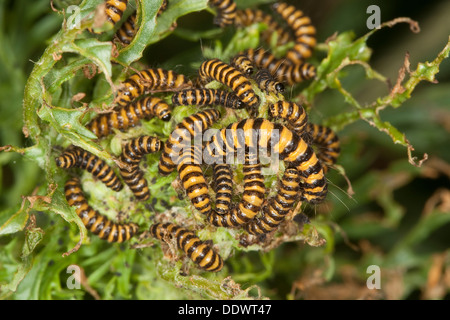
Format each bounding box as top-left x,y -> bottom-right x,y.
56,0 -> 340,272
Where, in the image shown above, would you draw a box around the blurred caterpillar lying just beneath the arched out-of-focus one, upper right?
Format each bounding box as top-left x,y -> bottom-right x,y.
243,48 -> 316,85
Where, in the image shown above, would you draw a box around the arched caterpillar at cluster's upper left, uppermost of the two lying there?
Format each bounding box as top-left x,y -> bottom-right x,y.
116,68 -> 192,106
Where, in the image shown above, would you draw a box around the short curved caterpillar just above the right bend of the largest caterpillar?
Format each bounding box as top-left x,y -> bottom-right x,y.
269,100 -> 308,135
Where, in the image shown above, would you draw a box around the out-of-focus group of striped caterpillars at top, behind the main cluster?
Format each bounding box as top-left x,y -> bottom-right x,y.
210,0 -> 317,89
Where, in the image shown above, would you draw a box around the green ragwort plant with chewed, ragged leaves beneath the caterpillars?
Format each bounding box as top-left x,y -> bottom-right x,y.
0,0 -> 450,299
